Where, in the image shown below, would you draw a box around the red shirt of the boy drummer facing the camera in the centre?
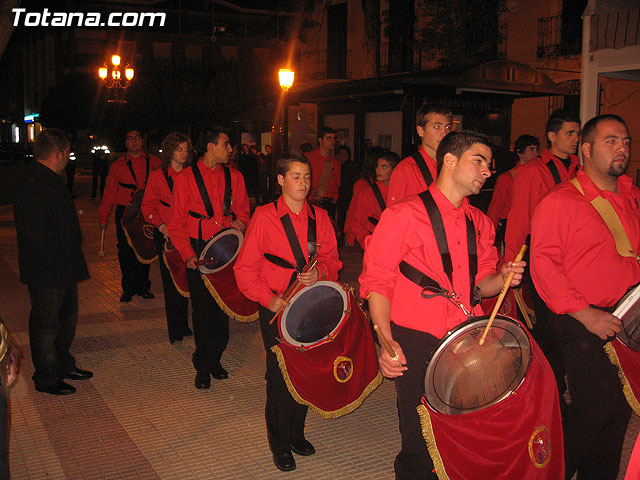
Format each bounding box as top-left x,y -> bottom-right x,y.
233,196 -> 342,307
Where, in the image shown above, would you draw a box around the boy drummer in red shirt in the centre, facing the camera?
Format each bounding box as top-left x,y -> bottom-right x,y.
234,157 -> 342,471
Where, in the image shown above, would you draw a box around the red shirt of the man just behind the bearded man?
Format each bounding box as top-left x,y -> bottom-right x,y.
504,150 -> 579,261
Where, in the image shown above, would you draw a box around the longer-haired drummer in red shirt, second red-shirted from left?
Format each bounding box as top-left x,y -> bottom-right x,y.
141,132 -> 193,343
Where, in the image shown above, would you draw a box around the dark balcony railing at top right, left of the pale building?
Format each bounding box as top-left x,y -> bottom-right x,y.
537,15 -> 582,58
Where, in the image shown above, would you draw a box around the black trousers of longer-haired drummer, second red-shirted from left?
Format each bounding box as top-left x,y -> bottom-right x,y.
153,229 -> 189,341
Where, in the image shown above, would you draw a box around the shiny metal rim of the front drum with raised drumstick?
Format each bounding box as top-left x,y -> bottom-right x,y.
423,314 -> 533,415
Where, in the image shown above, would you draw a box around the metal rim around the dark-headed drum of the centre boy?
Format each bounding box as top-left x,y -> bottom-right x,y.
278,280 -> 352,350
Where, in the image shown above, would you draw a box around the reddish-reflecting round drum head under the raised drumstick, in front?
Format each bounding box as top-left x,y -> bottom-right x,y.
425,315 -> 531,415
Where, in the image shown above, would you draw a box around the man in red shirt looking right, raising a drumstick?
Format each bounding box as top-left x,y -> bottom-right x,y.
360,130 -> 524,480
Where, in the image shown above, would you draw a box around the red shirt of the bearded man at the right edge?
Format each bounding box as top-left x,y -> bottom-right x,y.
531,170 -> 640,313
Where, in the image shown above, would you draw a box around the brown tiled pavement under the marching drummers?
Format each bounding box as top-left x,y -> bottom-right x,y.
0,175 -> 639,480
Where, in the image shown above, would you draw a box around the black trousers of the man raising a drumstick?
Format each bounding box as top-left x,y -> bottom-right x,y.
391,323 -> 440,480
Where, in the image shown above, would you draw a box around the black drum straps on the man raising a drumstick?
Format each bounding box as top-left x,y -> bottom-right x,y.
400,190 -> 481,315
